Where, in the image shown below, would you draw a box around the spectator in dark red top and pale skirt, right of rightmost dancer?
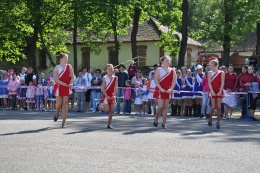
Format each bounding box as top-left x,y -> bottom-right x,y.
222,64 -> 237,119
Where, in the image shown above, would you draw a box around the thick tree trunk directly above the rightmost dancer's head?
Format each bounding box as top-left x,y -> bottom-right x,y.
222,0 -> 235,66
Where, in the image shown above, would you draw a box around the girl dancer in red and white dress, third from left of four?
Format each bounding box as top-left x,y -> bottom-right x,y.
153,56 -> 177,129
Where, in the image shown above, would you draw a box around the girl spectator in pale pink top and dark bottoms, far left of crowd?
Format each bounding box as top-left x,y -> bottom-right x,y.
7,73 -> 20,110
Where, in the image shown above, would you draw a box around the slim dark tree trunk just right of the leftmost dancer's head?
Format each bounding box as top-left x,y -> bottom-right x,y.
73,0 -> 78,74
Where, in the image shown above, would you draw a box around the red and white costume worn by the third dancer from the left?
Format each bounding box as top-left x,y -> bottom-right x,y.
153,67 -> 174,99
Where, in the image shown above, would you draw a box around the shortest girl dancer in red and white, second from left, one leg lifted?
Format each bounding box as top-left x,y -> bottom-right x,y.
97,64 -> 118,129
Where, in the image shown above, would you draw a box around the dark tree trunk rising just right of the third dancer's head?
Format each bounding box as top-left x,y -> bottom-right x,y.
178,0 -> 189,68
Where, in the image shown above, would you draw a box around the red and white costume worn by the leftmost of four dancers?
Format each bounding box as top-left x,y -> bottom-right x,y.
53,64 -> 72,96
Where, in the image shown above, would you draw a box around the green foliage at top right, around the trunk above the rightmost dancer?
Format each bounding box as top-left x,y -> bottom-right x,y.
189,0 -> 260,47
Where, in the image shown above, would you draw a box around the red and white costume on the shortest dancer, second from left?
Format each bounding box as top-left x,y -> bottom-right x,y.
101,75 -> 117,104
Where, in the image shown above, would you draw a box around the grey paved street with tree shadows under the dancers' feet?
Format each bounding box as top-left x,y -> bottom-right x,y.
0,111 -> 260,173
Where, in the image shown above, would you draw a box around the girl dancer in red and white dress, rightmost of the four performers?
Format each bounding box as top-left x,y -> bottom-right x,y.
208,60 -> 225,129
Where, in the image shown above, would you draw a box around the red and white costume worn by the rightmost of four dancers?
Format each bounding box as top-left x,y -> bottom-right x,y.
208,70 -> 225,98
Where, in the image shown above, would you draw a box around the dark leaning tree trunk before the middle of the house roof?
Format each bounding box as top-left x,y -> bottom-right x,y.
131,8 -> 142,61
